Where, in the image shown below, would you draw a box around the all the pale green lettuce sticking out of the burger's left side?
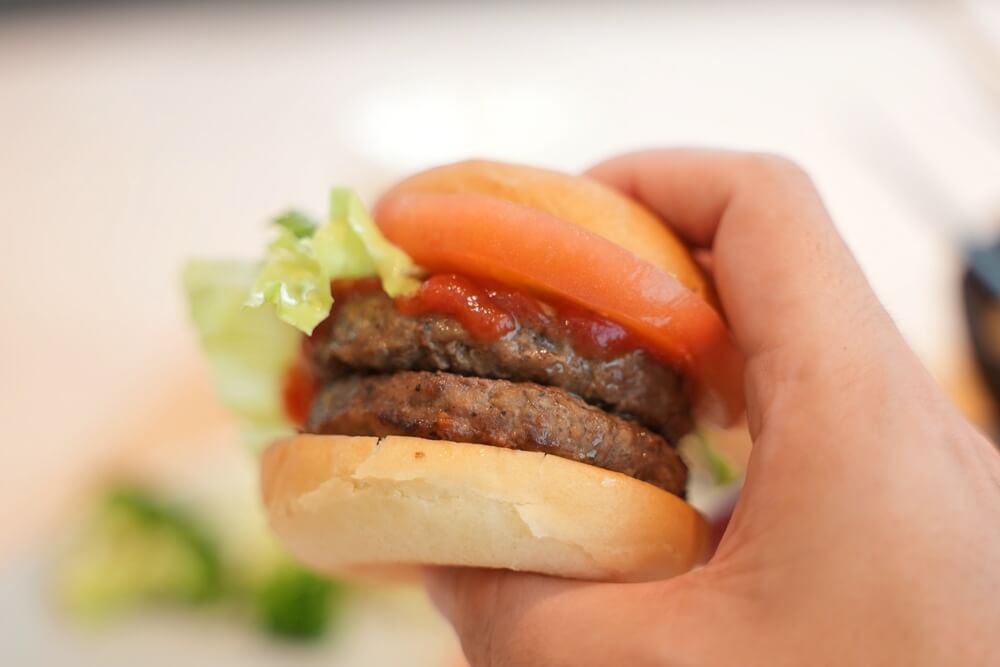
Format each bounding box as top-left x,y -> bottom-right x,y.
183,188 -> 420,449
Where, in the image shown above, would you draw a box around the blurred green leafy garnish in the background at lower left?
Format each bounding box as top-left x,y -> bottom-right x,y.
57,486 -> 346,641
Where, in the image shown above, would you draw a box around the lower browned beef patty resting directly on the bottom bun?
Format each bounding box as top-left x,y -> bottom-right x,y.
306,372 -> 687,497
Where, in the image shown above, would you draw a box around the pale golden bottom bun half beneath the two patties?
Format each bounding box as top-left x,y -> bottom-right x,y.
261,435 -> 706,581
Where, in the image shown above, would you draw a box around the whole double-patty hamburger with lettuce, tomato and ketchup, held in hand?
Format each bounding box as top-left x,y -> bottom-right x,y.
186,161 -> 742,581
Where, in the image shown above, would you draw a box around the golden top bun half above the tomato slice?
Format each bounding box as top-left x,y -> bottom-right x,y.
389,160 -> 714,301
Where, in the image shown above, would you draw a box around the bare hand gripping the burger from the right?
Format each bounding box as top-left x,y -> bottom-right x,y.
428,150 -> 1000,667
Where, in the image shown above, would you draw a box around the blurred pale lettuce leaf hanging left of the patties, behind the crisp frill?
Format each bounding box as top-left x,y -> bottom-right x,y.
183,260 -> 301,448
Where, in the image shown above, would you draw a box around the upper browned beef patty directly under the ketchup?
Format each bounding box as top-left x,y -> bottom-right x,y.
308,291 -> 692,442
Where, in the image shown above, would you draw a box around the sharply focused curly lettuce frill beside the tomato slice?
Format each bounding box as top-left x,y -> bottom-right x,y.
252,188 -> 419,334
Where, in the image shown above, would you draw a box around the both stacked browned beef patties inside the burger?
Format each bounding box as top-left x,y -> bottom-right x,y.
306,291 -> 691,496
